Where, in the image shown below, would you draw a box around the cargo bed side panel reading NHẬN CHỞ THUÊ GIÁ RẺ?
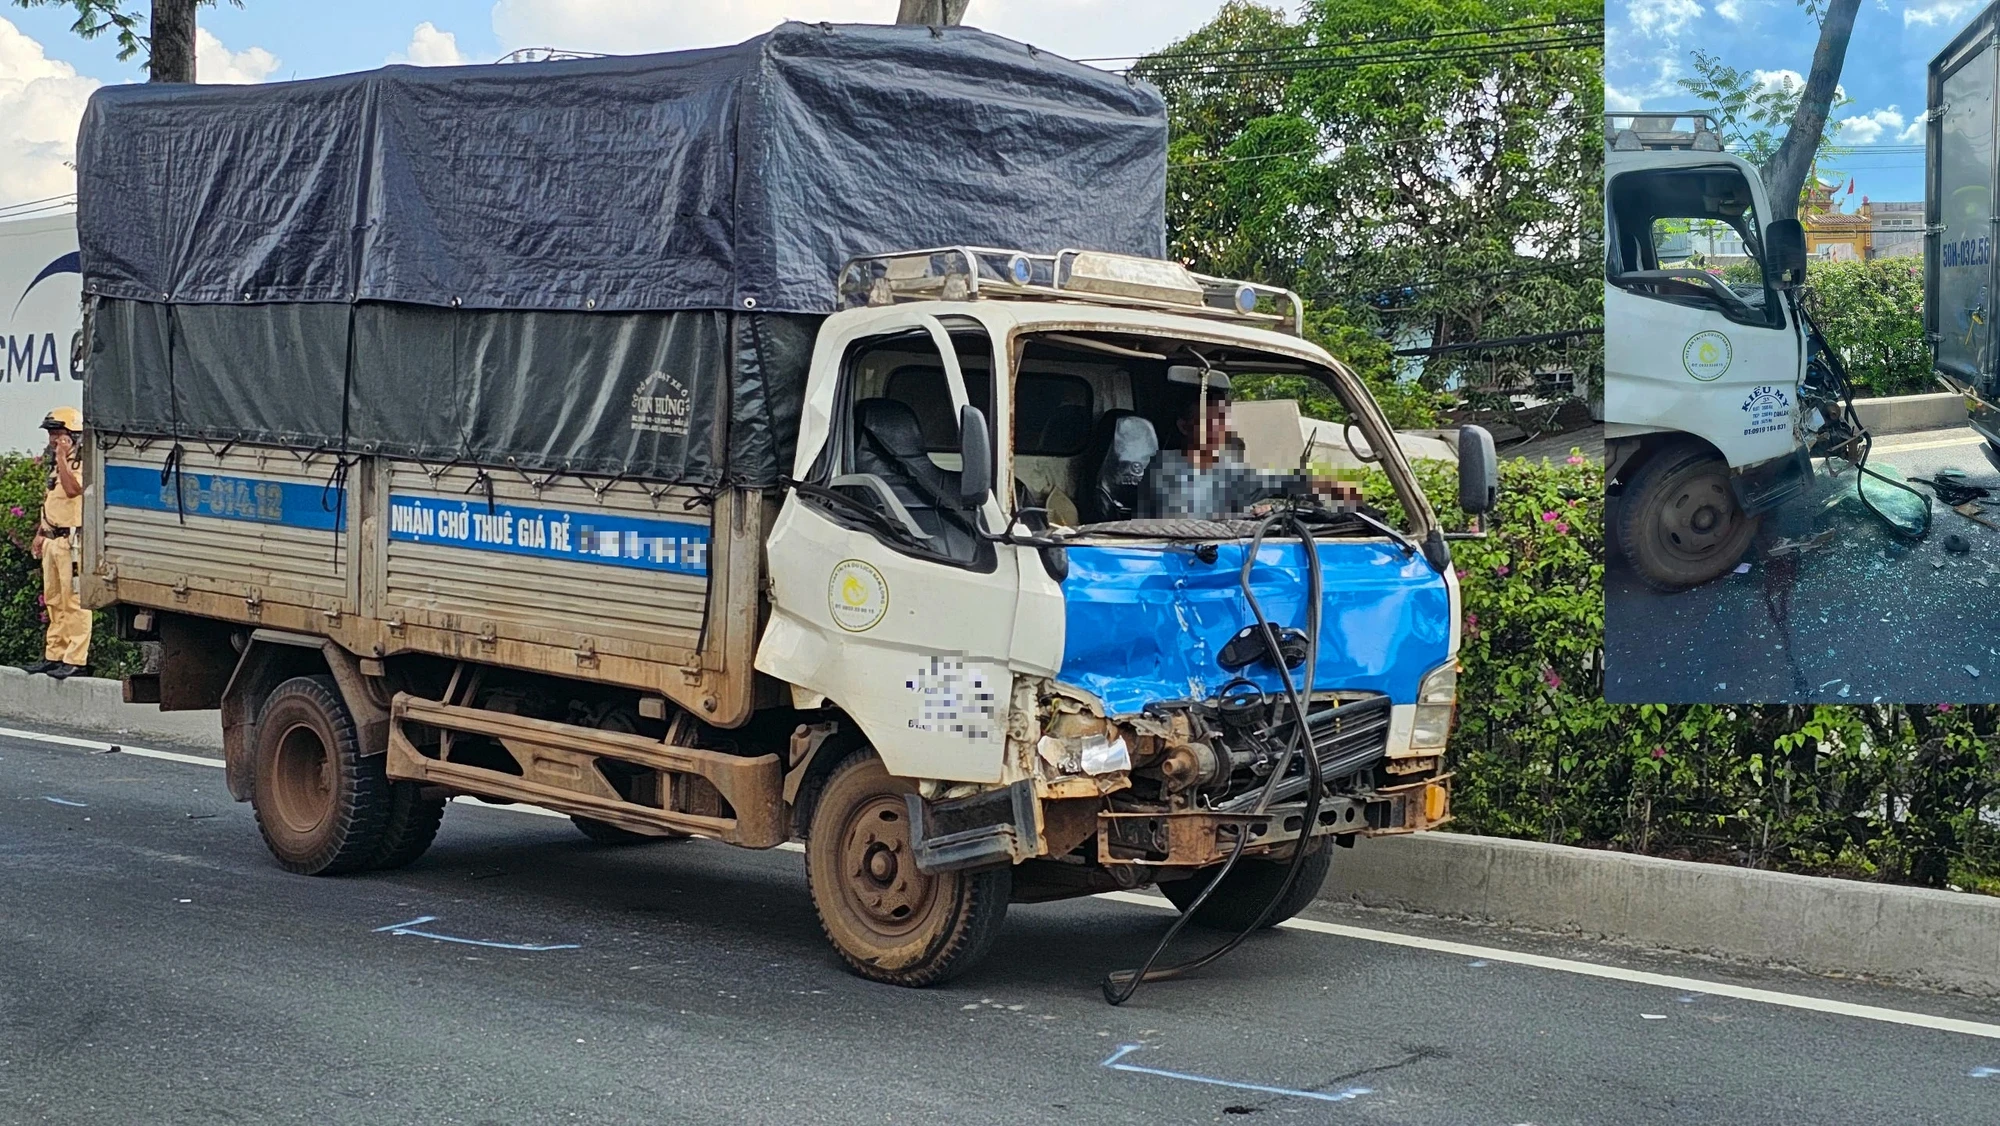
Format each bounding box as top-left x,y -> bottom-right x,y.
364,458 -> 764,726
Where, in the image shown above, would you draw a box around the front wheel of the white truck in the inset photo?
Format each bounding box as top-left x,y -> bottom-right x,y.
1618,446 -> 1758,592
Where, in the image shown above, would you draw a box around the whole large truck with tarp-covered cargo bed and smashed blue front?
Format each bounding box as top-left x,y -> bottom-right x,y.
78,24 -> 1494,986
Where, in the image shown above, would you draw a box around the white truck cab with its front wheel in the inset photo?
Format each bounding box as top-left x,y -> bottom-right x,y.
1604,114 -> 1832,590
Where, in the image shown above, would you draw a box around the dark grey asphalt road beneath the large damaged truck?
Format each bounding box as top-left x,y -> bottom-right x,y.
0,724 -> 2000,1126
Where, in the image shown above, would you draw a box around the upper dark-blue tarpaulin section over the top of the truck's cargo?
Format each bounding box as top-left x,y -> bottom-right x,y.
76,24 -> 1166,312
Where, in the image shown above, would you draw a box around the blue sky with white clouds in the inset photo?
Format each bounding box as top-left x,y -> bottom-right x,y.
1604,0 -> 1986,210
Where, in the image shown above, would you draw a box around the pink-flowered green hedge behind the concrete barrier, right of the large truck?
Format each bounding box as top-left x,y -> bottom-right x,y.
1384,456 -> 2000,892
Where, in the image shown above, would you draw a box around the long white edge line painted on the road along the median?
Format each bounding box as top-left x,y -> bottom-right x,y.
23,728 -> 2000,1040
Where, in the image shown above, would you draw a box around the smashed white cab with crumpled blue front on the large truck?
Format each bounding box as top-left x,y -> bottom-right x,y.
756,248 -> 1492,984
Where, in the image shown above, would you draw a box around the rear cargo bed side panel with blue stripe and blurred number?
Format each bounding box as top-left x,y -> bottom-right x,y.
86,442 -> 360,622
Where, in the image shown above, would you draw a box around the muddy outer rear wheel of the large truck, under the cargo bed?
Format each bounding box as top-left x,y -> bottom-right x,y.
250,676 -> 390,876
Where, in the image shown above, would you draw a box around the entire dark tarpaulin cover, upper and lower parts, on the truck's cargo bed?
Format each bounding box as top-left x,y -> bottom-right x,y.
78,24 -> 1166,486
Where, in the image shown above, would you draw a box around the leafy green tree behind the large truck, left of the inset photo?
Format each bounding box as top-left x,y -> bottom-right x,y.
1134,0 -> 1604,424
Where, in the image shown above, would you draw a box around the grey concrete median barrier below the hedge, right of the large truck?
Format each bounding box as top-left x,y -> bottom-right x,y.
1320,832 -> 2000,996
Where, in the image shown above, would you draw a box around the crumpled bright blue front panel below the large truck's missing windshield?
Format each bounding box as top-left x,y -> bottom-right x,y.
1056,540 -> 1452,716
